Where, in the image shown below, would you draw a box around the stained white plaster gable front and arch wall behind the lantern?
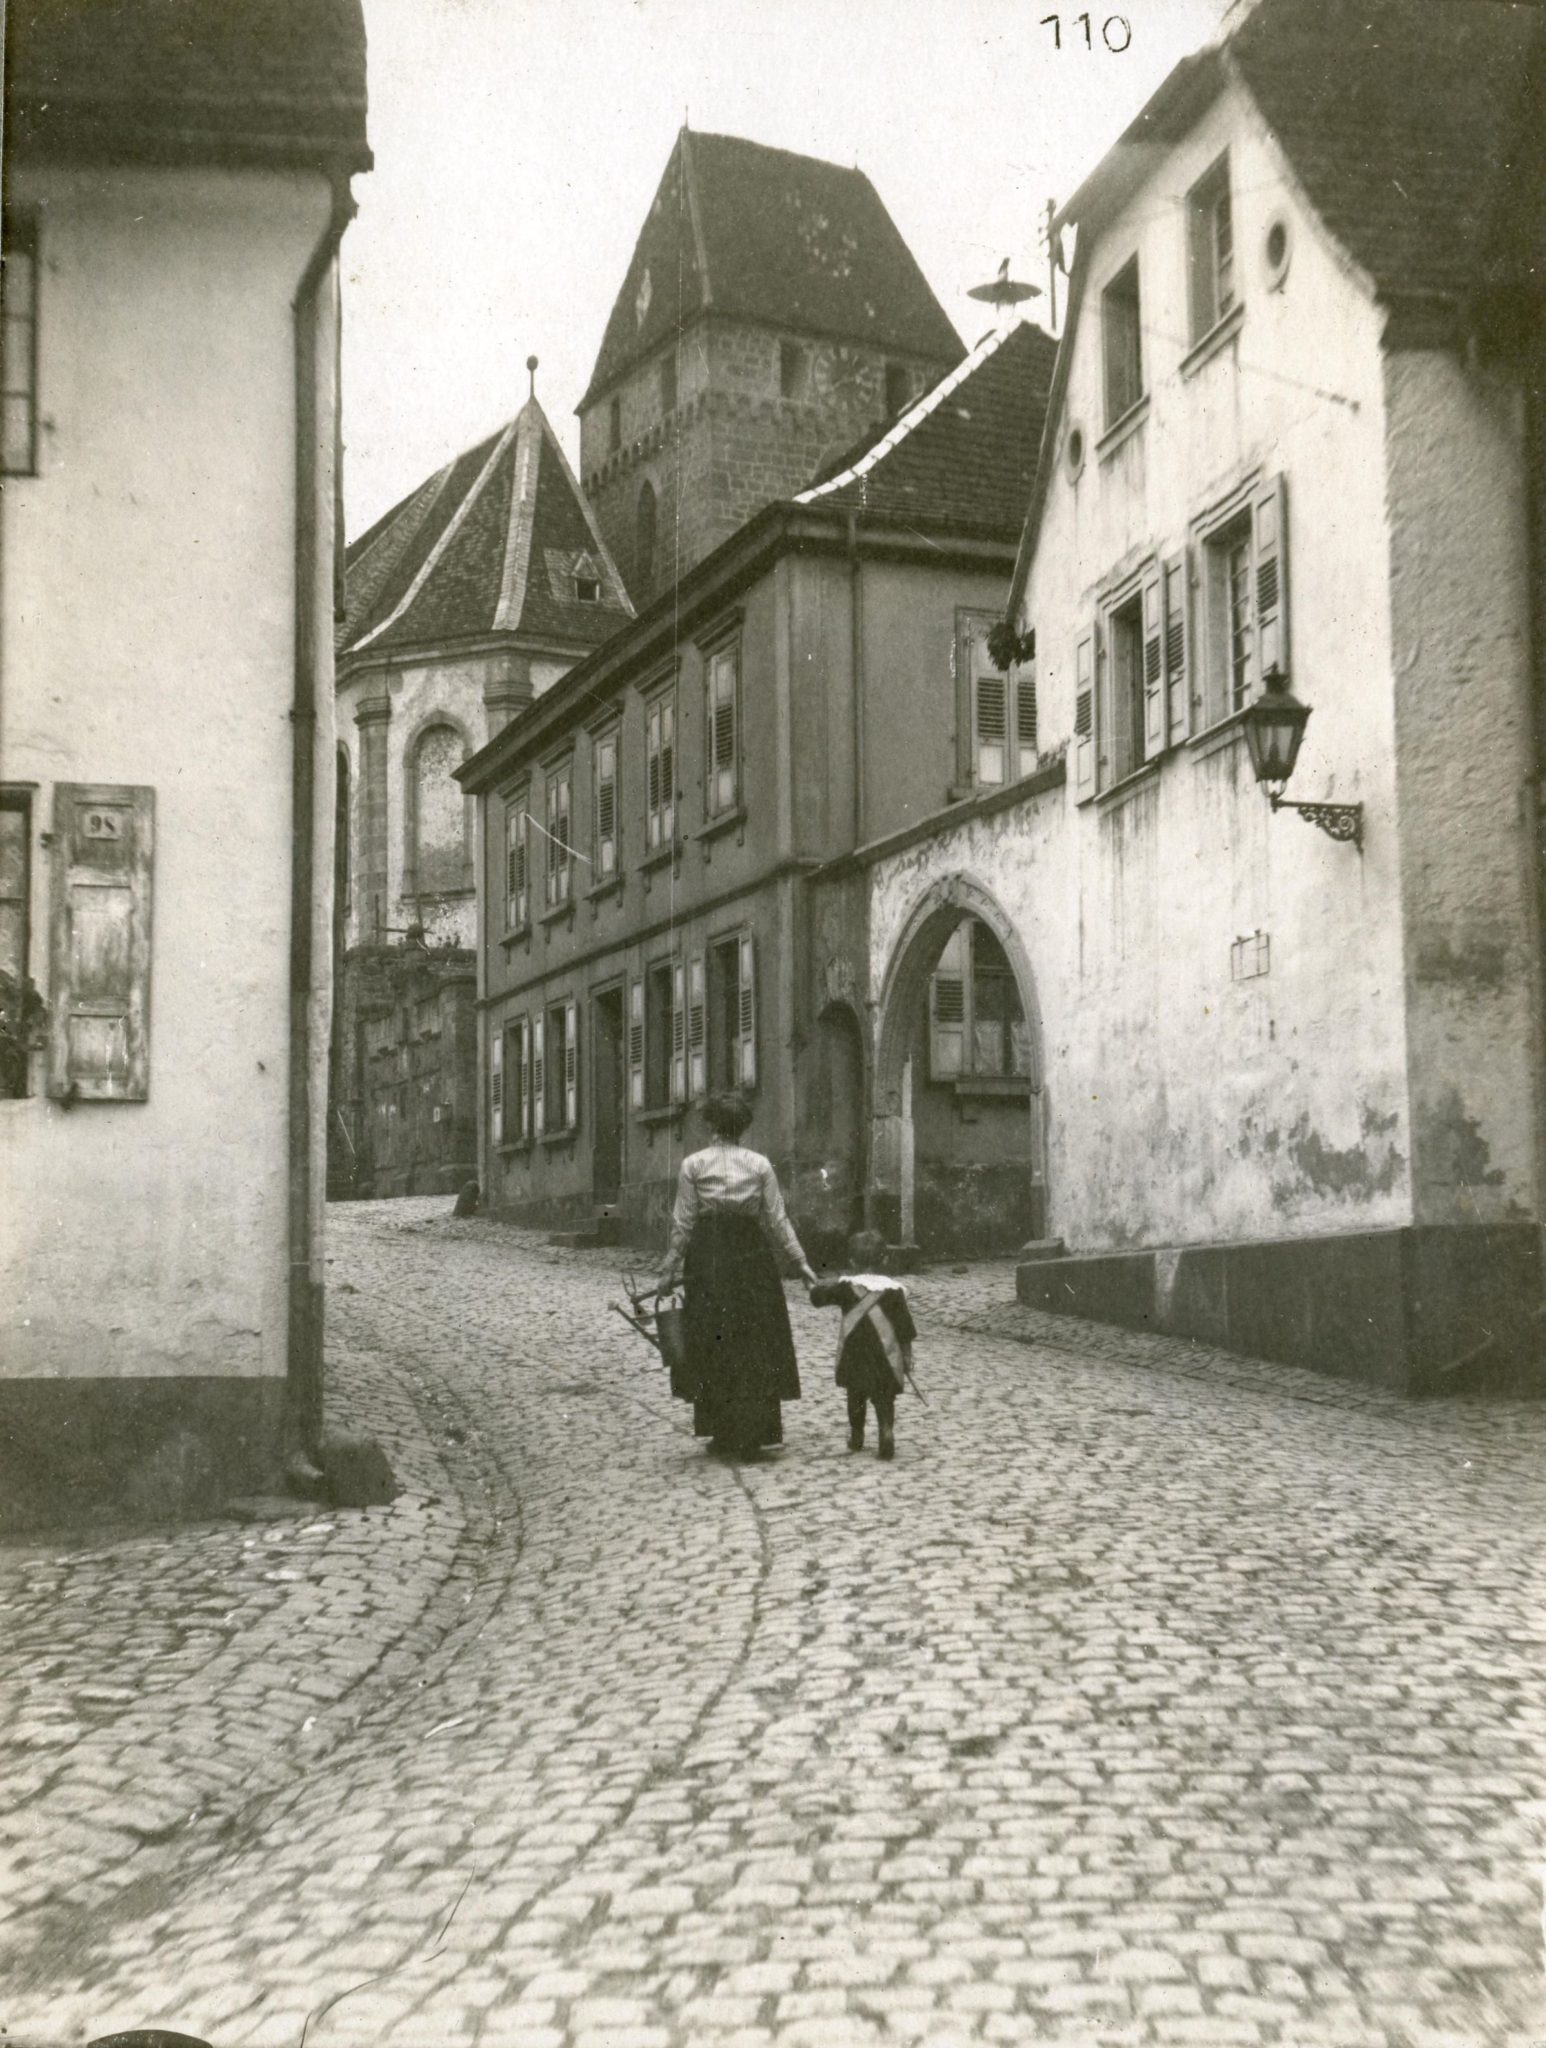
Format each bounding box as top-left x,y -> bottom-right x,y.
870,79 -> 1413,1249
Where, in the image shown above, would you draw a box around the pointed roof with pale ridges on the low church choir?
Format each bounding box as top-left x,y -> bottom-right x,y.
338,397 -> 633,655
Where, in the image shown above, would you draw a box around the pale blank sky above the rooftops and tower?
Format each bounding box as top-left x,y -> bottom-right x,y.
344,0 -> 1225,537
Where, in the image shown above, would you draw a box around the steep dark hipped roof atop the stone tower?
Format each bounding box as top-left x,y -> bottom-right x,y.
579,129 -> 962,410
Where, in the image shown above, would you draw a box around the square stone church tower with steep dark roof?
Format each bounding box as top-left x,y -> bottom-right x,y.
577,127 -> 964,608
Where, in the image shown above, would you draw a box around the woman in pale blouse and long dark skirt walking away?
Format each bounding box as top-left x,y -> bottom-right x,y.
661,1094 -> 815,1454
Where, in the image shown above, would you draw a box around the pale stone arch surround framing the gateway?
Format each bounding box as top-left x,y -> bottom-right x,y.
866,872 -> 1046,1241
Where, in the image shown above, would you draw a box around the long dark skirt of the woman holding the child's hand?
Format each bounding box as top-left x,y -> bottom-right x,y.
682,1210 -> 801,1450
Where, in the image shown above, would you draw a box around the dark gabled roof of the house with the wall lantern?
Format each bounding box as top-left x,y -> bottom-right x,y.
1063,0 -> 1546,299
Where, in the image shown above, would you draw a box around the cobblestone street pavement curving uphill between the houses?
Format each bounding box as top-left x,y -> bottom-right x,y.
0,1202 -> 1546,2048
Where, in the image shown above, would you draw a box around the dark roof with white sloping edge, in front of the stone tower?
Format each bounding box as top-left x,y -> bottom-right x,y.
795,322 -> 1057,537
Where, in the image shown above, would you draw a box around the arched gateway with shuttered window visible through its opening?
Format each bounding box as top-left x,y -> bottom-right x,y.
866,874 -> 1046,1253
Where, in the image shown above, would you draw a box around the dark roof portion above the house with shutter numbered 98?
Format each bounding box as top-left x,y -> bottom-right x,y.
6,0 -> 371,170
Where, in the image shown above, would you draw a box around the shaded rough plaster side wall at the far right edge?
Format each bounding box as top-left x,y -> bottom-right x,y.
1386,352 -> 1540,1223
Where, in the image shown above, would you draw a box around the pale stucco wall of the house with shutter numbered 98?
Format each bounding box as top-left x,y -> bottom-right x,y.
0,168 -> 334,1380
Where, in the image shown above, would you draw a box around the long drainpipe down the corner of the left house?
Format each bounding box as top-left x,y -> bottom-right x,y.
285,172 -> 354,1452
